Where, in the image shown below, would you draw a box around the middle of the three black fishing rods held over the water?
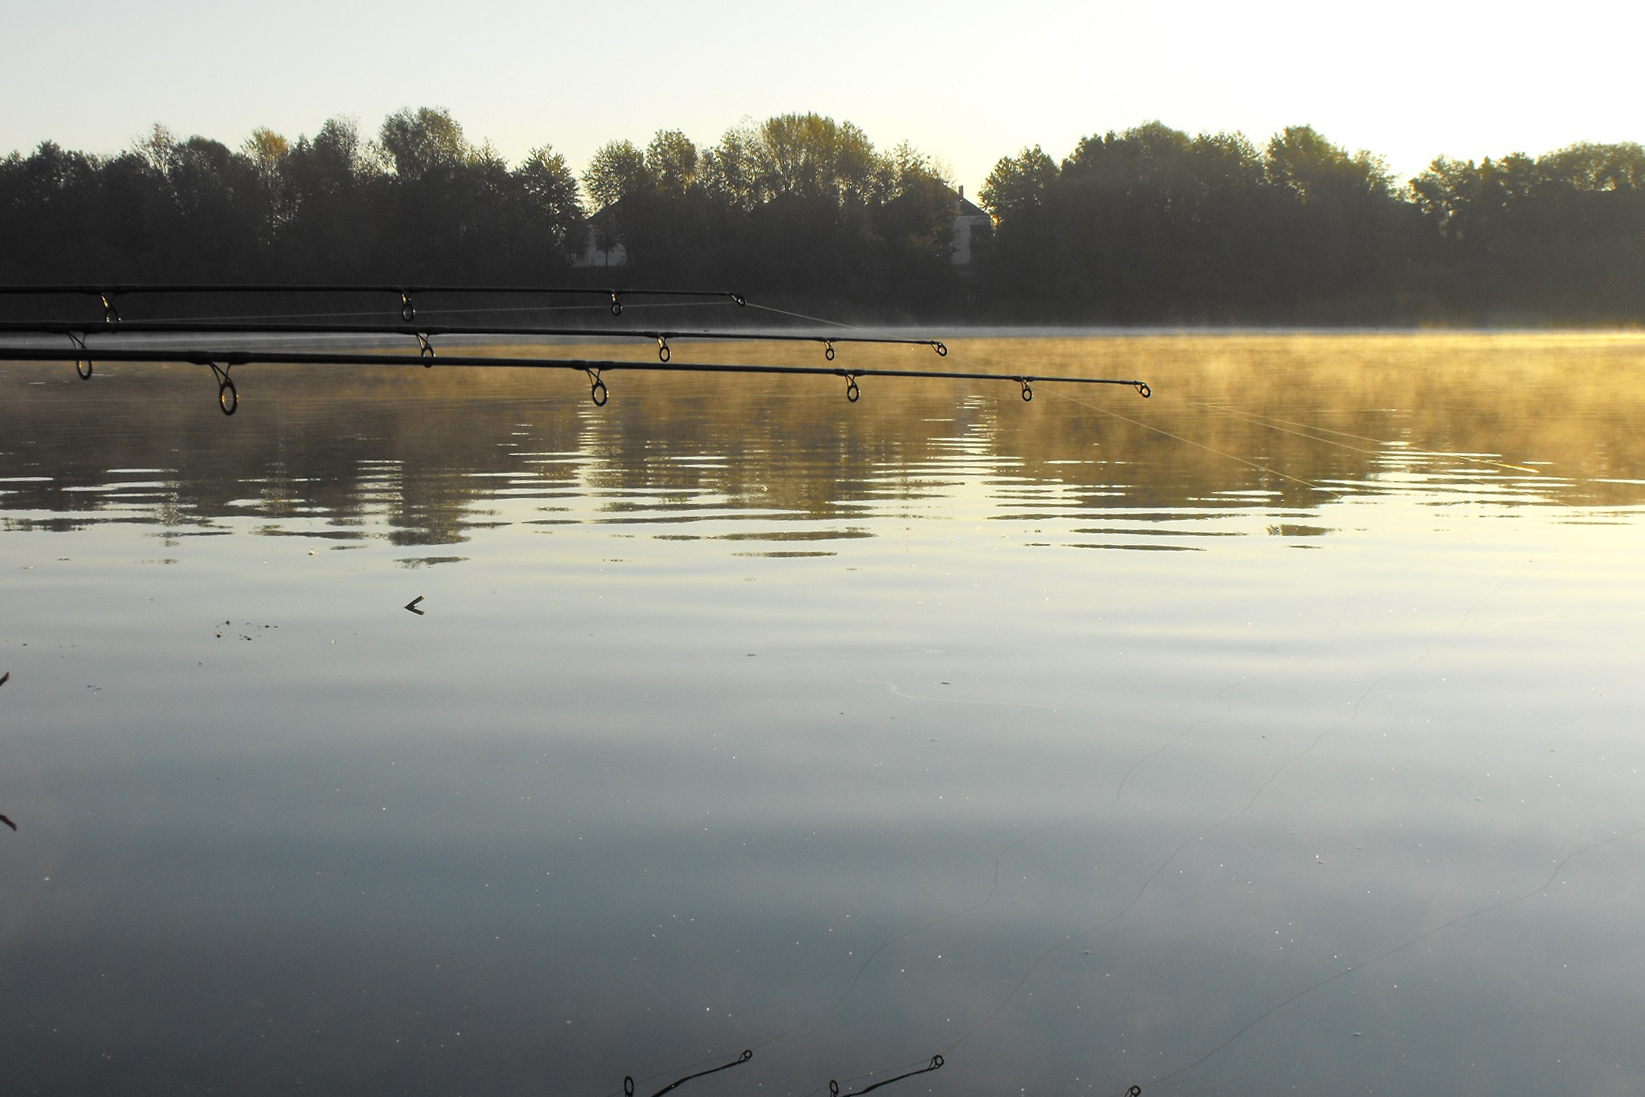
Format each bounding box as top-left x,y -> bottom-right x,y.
0,321 -> 948,362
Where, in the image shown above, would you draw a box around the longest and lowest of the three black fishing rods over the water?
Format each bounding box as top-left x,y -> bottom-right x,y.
0,344 -> 1152,414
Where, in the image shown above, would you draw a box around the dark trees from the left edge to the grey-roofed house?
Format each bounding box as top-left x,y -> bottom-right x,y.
0,109 -> 957,314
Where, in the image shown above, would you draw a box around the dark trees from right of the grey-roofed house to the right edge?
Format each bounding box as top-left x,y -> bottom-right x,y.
980,123 -> 1645,324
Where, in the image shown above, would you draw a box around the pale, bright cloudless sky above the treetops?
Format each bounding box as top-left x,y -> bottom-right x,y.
0,0 -> 1645,194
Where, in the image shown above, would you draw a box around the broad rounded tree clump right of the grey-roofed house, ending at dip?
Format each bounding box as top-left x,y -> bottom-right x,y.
982,122 -> 1415,322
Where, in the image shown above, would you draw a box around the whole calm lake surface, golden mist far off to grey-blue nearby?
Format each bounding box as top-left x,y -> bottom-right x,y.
0,336 -> 1645,1097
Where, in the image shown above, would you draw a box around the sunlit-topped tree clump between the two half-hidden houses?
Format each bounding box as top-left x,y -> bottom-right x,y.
582,113 -> 954,314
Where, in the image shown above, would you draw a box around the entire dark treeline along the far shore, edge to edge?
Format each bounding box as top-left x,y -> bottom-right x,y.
0,109 -> 1645,324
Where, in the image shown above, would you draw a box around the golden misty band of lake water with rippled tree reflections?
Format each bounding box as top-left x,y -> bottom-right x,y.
0,334 -> 1645,544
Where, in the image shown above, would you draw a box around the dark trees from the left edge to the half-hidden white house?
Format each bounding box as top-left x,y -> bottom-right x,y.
0,110 -> 582,283
